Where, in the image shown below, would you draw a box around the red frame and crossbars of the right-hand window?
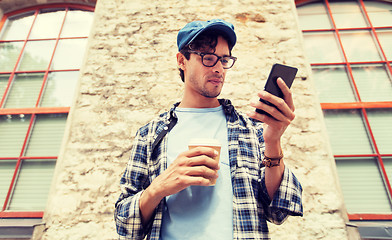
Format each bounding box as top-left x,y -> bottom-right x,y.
295,0 -> 392,221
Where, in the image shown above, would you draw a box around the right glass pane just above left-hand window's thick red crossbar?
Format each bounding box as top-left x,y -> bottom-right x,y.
41,71 -> 79,107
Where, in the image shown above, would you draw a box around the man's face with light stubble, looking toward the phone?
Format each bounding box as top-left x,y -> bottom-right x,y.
183,37 -> 230,98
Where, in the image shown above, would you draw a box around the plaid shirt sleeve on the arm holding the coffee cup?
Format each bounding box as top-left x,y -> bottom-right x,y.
114,129 -> 148,239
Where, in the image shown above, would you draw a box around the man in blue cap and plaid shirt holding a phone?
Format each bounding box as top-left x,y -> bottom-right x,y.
115,19 -> 302,239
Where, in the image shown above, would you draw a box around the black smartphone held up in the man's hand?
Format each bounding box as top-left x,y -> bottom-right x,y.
256,63 -> 298,117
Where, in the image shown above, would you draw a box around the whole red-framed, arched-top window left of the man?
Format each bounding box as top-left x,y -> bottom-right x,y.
0,4 -> 94,218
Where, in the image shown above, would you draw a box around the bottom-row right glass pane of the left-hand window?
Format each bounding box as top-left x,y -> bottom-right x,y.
8,160 -> 56,211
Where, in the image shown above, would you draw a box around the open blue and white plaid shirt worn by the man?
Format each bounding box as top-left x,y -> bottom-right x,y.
115,99 -> 303,240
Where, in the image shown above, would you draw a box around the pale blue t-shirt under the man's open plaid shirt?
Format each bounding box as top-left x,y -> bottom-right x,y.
160,106 -> 233,240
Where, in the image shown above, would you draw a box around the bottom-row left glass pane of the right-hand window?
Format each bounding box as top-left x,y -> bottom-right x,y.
336,159 -> 391,213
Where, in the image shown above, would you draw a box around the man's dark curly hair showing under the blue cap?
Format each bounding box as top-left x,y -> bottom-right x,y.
178,31 -> 233,82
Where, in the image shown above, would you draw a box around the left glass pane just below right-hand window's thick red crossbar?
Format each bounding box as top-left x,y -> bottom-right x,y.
324,110 -> 373,155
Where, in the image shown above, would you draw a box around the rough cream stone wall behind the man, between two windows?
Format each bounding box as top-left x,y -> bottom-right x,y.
26,0 -> 357,240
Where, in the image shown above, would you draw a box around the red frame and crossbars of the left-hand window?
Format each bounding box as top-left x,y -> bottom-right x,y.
0,3 -> 95,218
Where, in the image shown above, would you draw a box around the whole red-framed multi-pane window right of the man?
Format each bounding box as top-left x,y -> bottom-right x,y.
296,0 -> 392,221
